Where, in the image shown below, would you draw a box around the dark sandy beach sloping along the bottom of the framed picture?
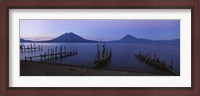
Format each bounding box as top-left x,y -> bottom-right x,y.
20,60 -> 173,76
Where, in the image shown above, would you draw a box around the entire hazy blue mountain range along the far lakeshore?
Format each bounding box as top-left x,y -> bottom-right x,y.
20,32 -> 180,45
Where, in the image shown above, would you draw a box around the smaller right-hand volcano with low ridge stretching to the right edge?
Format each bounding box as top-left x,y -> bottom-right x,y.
109,35 -> 180,45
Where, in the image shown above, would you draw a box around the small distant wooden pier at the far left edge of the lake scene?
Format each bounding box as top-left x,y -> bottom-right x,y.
20,44 -> 43,52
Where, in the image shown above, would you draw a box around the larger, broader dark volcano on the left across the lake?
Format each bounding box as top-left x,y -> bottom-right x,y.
46,32 -> 97,43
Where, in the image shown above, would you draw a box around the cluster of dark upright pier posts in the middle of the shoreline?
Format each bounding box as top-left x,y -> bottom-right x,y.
93,44 -> 112,67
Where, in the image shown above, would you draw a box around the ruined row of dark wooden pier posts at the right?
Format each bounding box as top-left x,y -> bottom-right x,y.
135,51 -> 178,75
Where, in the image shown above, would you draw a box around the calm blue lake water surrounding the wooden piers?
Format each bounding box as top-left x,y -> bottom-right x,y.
20,43 -> 180,73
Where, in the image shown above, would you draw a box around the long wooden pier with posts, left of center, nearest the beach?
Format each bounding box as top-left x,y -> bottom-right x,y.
25,46 -> 78,61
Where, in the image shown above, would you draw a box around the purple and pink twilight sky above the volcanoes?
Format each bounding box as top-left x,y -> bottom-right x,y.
20,19 -> 180,41
